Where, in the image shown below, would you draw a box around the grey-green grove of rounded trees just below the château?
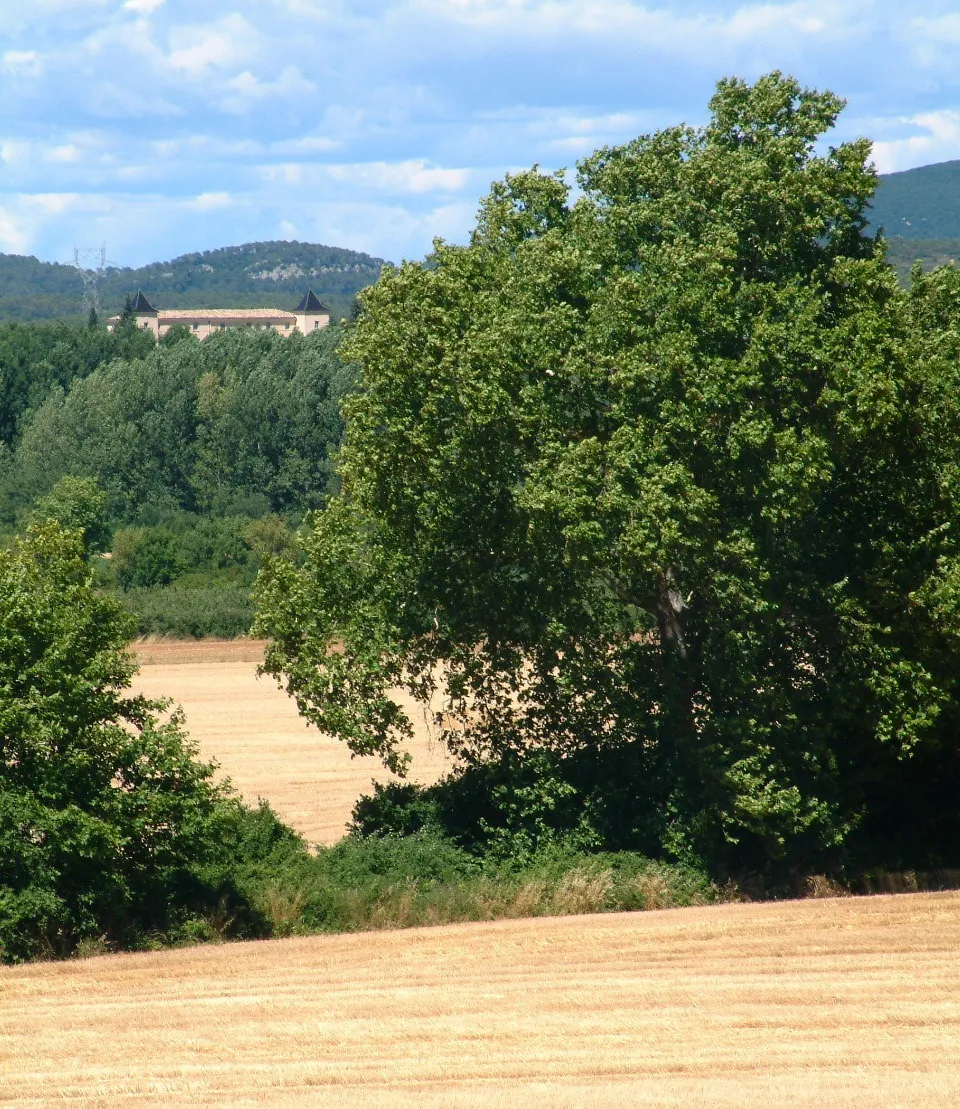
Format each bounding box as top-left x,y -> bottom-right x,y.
7,328 -> 351,521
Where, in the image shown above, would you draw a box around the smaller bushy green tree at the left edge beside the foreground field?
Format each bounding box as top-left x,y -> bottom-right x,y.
0,521 -> 238,962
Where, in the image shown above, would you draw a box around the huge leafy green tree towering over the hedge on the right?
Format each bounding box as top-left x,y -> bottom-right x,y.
259,73 -> 960,869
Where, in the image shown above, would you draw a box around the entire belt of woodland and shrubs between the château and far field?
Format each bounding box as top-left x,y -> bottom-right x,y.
0,324 -> 353,635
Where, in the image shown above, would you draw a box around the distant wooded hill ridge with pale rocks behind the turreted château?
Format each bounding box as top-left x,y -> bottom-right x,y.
0,242 -> 385,322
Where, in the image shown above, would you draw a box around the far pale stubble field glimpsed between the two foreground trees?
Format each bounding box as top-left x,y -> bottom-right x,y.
134,640 -> 447,844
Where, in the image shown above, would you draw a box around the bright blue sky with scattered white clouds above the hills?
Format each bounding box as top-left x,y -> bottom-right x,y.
0,0 -> 960,265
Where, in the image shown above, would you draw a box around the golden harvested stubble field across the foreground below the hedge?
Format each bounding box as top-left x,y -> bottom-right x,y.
0,893 -> 960,1109
